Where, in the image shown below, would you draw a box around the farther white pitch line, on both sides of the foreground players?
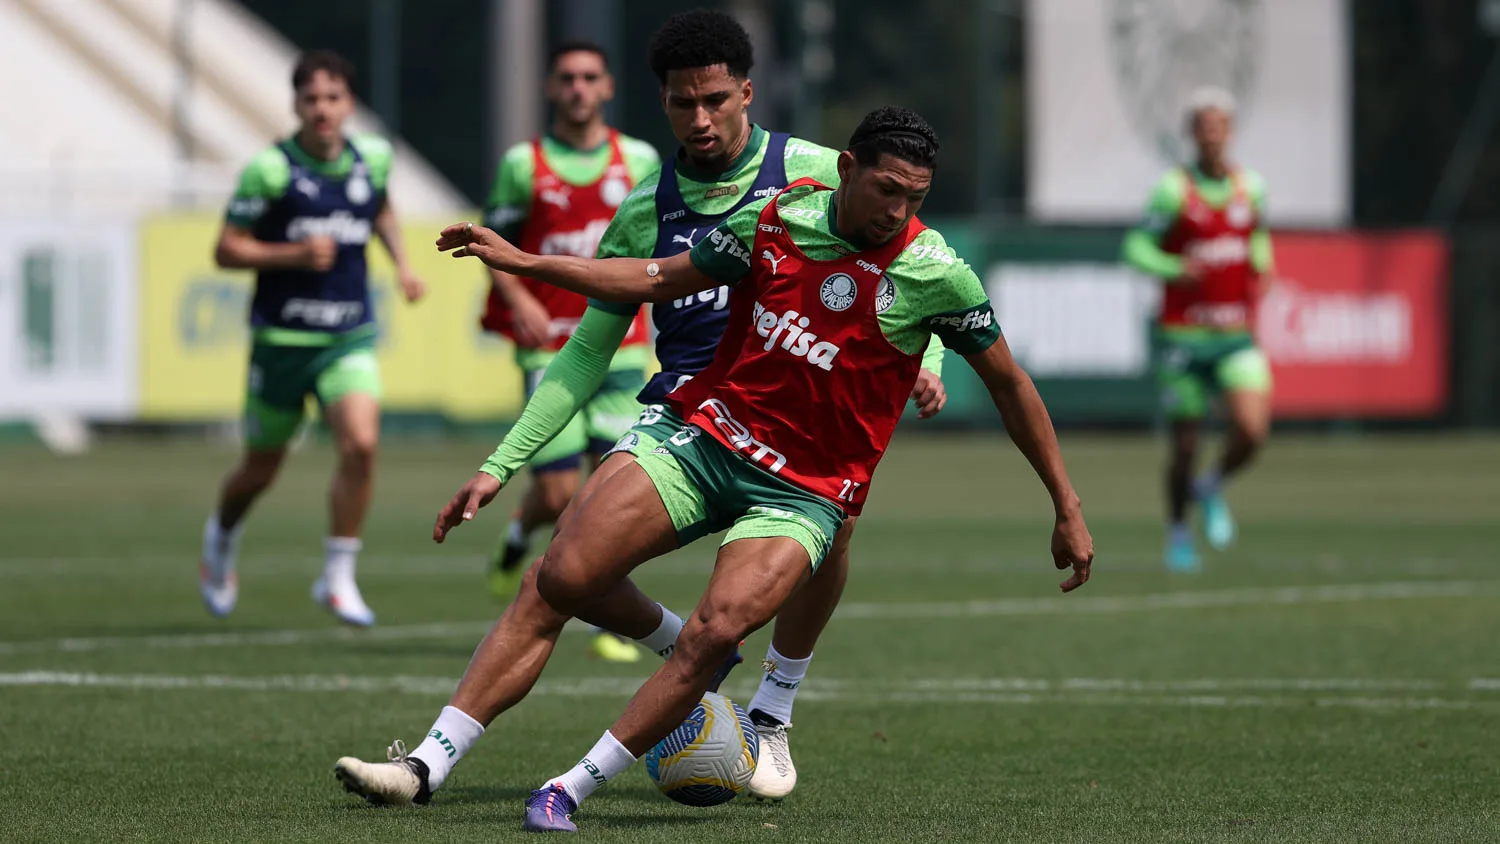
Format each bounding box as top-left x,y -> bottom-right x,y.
0,580 -> 1500,657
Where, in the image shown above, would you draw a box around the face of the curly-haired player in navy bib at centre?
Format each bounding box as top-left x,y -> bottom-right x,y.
662,64 -> 755,169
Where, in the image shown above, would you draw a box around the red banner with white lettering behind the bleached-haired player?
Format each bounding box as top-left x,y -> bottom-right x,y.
1257,232 -> 1451,417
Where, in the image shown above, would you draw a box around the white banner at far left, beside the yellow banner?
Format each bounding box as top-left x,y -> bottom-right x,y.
0,217 -> 137,420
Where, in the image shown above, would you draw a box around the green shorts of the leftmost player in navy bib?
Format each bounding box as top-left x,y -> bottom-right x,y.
245,331 -> 381,451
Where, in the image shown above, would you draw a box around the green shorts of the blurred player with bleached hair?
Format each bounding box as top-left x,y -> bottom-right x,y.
1155,328 -> 1271,420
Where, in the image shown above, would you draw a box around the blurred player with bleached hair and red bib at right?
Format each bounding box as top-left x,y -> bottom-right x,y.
1124,88 -> 1272,571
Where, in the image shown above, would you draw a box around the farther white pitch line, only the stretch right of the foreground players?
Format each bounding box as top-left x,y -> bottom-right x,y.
837,580 -> 1500,619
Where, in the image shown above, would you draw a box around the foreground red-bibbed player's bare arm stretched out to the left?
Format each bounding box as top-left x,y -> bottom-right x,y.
438,223 -> 722,301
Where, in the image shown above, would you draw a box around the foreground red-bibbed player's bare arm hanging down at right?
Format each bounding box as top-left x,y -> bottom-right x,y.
965,336 -> 1094,592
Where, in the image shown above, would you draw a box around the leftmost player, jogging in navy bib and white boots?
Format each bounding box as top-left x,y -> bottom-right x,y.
198,51 -> 425,625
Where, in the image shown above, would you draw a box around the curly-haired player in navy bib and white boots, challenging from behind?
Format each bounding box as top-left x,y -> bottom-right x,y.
336,10 -> 947,804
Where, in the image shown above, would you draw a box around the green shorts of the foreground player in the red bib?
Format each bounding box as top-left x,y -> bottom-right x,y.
627,405 -> 845,570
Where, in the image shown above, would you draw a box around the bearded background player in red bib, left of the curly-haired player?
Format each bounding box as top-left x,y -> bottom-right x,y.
482,40 -> 662,663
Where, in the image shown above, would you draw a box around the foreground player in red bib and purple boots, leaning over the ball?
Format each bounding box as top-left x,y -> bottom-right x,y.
434,108 -> 1094,832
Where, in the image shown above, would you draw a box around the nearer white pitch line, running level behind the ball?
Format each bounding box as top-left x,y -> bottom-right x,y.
0,670 -> 1500,711
